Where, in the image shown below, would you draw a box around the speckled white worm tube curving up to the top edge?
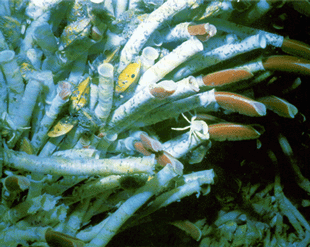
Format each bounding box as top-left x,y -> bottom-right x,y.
119,0 -> 202,71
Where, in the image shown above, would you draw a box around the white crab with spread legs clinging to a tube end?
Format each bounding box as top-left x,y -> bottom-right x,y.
171,113 -> 210,146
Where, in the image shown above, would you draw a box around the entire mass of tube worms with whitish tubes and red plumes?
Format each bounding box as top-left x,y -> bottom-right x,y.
0,0 -> 310,247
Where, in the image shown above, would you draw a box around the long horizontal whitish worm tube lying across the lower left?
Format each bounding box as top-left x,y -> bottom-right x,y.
6,150 -> 156,176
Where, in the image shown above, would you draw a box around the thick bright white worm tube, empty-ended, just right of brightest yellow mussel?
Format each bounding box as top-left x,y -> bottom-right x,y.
136,38 -> 203,89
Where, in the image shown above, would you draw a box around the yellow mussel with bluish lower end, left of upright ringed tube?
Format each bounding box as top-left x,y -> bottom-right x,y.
71,77 -> 90,110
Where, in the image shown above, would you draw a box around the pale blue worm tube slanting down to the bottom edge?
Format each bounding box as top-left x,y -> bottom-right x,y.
86,164 -> 182,247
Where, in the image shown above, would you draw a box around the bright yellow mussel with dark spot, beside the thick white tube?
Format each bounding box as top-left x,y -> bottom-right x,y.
115,60 -> 141,93
